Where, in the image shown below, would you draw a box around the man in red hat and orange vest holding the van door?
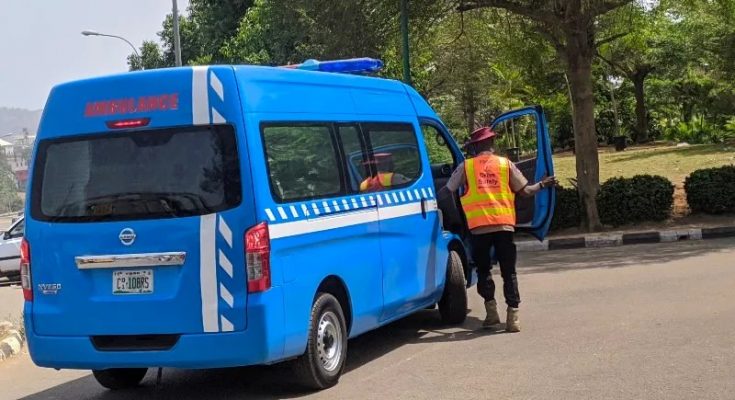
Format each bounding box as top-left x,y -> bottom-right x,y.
447,127 -> 557,332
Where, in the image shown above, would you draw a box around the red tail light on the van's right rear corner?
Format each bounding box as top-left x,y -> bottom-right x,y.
245,222 -> 271,293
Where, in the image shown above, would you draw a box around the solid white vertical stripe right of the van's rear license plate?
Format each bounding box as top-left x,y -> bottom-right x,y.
199,214 -> 219,332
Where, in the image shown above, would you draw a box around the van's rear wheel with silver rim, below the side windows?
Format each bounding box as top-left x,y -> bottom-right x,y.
293,293 -> 347,389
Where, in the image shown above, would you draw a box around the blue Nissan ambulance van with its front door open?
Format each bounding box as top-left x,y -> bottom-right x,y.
21,59 -> 553,389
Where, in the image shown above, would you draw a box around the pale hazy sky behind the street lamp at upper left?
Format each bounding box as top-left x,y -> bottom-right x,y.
0,0 -> 189,110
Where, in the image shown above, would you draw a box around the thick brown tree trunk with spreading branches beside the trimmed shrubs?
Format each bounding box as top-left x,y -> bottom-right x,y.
459,0 -> 633,231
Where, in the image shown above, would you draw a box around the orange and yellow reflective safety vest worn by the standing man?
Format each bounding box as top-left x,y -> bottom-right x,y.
460,155 -> 516,229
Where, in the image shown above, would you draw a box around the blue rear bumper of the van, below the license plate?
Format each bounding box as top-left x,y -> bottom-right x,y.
25,288 -> 284,369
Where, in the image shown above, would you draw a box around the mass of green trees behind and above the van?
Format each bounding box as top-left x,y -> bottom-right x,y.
134,0 -> 735,229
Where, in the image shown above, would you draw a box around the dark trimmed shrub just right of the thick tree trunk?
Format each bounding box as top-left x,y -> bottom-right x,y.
597,175 -> 674,226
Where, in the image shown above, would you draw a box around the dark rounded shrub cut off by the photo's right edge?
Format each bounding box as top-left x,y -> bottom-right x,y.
684,165 -> 735,214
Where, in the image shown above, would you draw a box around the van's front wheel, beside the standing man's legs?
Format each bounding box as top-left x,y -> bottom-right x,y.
439,251 -> 467,324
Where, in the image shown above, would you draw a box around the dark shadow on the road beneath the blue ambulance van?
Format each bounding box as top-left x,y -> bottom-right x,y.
24,310 -> 505,400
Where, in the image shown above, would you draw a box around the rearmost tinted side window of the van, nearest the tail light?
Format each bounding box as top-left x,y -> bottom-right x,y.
262,124 -> 344,202
